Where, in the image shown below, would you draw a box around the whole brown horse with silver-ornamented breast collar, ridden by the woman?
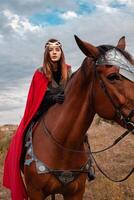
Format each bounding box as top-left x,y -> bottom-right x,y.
24,36 -> 134,200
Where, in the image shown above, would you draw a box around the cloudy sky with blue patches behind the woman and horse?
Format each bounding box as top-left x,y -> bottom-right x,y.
0,0 -> 134,124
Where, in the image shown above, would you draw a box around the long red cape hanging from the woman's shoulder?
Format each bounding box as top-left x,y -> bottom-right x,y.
3,70 -> 48,200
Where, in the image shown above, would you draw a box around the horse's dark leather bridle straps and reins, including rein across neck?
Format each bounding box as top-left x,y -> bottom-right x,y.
42,56 -> 134,182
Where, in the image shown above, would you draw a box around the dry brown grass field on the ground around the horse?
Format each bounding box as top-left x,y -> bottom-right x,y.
0,118 -> 134,200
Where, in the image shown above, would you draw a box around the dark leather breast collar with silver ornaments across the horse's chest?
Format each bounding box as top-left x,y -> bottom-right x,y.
24,125 -> 91,185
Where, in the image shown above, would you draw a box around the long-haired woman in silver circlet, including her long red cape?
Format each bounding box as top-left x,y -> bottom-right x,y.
3,39 -> 71,200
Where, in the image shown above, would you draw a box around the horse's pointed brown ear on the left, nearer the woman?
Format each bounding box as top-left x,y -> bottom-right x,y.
74,35 -> 100,58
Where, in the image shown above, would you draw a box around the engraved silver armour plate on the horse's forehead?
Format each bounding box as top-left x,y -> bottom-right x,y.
96,48 -> 134,82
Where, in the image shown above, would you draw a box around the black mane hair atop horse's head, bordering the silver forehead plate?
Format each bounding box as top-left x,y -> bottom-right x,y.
97,45 -> 133,64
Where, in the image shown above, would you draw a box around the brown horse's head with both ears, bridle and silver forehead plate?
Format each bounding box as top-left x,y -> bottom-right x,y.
75,36 -> 134,129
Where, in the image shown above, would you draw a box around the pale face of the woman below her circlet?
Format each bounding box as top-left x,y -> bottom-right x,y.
49,45 -> 61,62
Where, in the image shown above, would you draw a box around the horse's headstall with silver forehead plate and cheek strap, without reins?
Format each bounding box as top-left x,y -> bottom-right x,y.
94,45 -> 134,131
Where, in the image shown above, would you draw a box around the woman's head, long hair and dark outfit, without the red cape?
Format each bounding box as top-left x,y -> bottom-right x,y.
37,39 -> 71,118
